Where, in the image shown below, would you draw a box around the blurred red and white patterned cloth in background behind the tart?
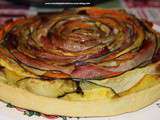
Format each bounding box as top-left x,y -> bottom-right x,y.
0,0 -> 160,25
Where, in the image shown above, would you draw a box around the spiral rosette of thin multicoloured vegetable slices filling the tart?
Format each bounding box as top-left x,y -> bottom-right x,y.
0,8 -> 160,99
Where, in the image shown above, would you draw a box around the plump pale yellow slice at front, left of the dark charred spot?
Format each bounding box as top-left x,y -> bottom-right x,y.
17,78 -> 76,97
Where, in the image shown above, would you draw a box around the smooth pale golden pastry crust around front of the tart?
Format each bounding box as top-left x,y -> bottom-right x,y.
0,79 -> 160,117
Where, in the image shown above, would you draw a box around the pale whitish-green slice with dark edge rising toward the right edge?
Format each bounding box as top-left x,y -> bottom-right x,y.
89,62 -> 160,93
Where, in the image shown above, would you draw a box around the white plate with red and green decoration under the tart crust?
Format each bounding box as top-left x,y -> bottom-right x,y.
0,100 -> 160,120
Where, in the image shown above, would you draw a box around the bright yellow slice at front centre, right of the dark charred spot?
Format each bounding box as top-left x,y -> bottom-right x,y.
61,81 -> 117,101
